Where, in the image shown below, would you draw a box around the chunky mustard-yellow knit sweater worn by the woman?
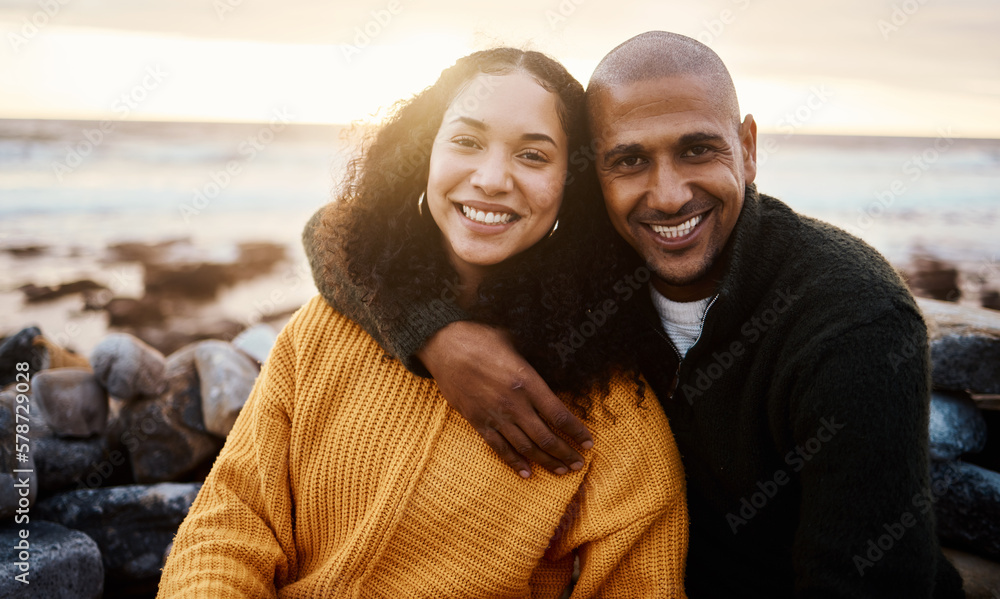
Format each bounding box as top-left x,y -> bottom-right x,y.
159,297 -> 688,599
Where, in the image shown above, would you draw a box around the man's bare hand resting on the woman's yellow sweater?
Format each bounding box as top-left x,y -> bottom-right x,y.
417,321 -> 594,478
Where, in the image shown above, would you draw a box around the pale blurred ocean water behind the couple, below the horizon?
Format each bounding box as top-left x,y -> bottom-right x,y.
0,119 -> 1000,348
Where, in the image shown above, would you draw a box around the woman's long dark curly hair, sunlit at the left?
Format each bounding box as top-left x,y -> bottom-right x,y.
317,48 -> 648,418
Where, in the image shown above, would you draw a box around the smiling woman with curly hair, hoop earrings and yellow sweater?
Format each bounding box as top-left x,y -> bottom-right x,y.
160,48 -> 687,598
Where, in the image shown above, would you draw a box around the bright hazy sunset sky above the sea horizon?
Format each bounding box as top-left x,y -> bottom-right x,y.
0,0 -> 1000,138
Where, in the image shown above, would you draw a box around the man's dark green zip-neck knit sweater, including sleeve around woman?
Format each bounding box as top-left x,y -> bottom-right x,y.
305,187 -> 964,599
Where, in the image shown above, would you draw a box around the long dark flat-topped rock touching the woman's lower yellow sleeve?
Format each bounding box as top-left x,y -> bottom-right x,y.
32,483 -> 201,581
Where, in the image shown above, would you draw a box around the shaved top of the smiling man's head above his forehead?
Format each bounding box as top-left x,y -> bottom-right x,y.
587,31 -> 740,126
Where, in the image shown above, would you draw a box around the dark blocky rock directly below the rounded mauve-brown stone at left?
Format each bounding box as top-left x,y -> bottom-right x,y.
32,437 -> 108,492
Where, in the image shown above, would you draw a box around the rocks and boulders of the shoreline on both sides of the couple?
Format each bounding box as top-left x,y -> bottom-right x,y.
0,244 -> 1000,599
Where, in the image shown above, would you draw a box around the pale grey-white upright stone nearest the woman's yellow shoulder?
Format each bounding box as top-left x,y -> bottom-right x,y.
194,341 -> 258,439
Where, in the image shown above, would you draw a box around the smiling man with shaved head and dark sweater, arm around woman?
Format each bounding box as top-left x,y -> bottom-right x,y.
306,32 -> 964,598
